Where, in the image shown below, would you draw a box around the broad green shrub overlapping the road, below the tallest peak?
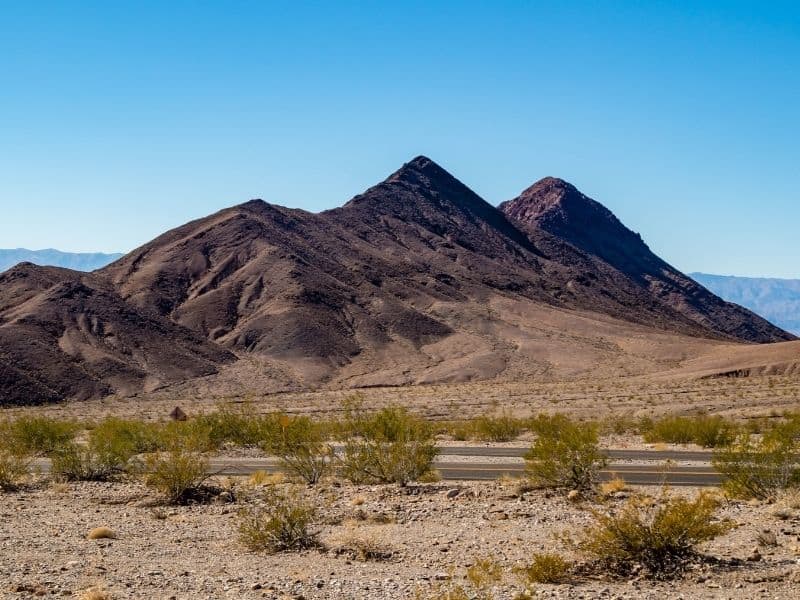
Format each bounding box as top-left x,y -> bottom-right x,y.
341,407 -> 436,485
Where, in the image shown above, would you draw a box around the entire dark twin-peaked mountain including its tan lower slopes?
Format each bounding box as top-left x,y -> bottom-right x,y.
0,156 -> 800,404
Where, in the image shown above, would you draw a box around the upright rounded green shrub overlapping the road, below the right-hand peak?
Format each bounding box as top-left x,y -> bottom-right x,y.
525,415 -> 607,492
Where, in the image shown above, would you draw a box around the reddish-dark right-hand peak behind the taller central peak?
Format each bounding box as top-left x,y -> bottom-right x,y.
500,177 -> 792,342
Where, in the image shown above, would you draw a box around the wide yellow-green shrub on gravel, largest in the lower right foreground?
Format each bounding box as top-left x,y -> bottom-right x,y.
578,492 -> 731,578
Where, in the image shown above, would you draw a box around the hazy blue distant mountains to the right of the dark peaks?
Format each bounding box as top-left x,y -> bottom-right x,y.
691,273 -> 800,335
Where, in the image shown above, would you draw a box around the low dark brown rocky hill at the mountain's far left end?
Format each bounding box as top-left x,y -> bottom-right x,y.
0,263 -> 234,404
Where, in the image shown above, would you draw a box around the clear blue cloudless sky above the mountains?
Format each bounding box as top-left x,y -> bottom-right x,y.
0,0 -> 800,277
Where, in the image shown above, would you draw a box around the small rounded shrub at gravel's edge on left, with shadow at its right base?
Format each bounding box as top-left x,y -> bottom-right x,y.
139,447 -> 209,504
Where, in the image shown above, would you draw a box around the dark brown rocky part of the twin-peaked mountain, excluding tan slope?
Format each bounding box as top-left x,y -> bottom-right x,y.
0,157 -> 791,404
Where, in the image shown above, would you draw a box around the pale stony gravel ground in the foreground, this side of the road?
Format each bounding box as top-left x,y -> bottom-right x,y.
0,480 -> 800,599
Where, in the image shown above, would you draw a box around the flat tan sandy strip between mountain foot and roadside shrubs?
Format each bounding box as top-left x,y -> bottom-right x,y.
4,375 -> 800,420
